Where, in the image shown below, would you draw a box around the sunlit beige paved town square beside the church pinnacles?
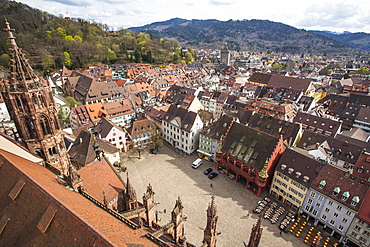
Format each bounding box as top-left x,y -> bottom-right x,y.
121,146 -> 304,246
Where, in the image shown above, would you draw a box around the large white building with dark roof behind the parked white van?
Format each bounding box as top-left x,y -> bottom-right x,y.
162,105 -> 203,154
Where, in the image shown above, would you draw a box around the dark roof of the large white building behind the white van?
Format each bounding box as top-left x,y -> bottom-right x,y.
163,105 -> 197,132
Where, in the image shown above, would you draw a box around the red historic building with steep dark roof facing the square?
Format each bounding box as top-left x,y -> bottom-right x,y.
216,122 -> 285,196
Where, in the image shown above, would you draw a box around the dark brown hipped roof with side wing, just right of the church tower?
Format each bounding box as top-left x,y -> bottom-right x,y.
68,130 -> 119,166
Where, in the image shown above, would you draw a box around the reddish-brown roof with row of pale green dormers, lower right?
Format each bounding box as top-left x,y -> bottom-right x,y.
311,164 -> 370,211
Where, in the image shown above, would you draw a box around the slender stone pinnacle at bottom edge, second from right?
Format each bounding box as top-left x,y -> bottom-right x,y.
202,196 -> 218,247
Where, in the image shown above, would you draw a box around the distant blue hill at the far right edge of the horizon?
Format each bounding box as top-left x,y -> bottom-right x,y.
310,30 -> 370,52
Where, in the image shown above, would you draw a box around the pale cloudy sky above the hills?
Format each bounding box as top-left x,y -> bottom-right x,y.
20,0 -> 370,33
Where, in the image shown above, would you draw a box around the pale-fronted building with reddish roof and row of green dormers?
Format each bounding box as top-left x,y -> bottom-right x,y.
302,164 -> 370,241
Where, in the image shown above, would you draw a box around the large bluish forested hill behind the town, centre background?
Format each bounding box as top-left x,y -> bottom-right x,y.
129,18 -> 364,55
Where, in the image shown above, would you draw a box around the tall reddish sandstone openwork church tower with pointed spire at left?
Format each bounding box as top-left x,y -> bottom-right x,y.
1,21 -> 70,175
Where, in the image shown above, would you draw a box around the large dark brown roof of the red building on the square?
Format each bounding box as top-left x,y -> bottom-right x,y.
222,123 -> 279,170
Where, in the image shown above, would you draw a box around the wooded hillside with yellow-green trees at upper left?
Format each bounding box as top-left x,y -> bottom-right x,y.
0,0 -> 185,72
